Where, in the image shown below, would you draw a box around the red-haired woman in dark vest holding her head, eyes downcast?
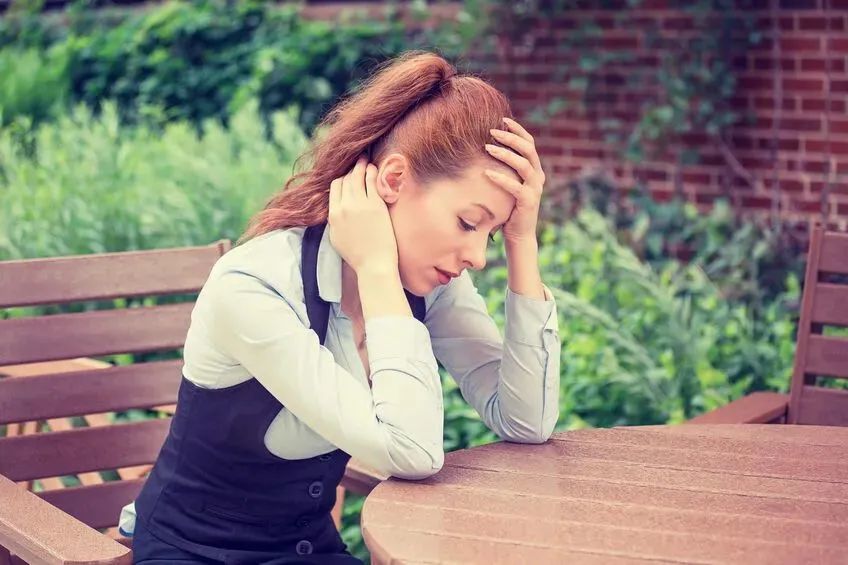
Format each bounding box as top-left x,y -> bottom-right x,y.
122,52 -> 560,564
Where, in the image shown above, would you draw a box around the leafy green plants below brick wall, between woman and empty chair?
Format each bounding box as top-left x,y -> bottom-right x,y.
468,208 -> 798,428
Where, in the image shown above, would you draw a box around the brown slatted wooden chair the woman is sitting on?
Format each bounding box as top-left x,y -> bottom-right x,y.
0,245 -> 382,565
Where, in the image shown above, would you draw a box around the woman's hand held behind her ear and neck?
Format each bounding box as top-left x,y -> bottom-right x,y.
327,155 -> 398,274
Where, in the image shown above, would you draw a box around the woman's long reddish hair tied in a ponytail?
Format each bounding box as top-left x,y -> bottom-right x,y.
239,51 -> 512,243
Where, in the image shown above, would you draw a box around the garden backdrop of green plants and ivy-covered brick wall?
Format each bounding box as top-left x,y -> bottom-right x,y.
0,0 -> 848,557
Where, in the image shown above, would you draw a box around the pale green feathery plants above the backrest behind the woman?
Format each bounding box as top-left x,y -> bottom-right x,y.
0,104 -> 306,259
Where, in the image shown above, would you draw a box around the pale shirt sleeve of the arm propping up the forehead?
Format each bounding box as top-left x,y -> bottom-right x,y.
427,273 -> 560,443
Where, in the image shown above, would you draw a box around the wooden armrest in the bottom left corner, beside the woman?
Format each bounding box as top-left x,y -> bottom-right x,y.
0,475 -> 132,565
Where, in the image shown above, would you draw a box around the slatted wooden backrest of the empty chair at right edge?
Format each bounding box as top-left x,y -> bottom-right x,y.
787,226 -> 848,426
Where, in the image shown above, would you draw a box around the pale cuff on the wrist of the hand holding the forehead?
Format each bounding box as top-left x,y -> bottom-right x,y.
504,285 -> 559,347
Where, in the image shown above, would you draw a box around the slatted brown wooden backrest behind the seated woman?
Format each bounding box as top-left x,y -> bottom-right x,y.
0,241 -> 230,528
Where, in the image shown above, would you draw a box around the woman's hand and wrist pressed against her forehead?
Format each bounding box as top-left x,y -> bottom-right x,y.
485,118 -> 545,243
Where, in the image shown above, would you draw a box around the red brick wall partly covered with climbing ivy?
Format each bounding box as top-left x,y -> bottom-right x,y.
460,0 -> 848,230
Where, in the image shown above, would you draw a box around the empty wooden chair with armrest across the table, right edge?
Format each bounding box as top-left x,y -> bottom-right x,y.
687,226 -> 848,426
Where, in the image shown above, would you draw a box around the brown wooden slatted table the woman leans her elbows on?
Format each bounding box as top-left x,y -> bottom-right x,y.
362,424 -> 848,565
